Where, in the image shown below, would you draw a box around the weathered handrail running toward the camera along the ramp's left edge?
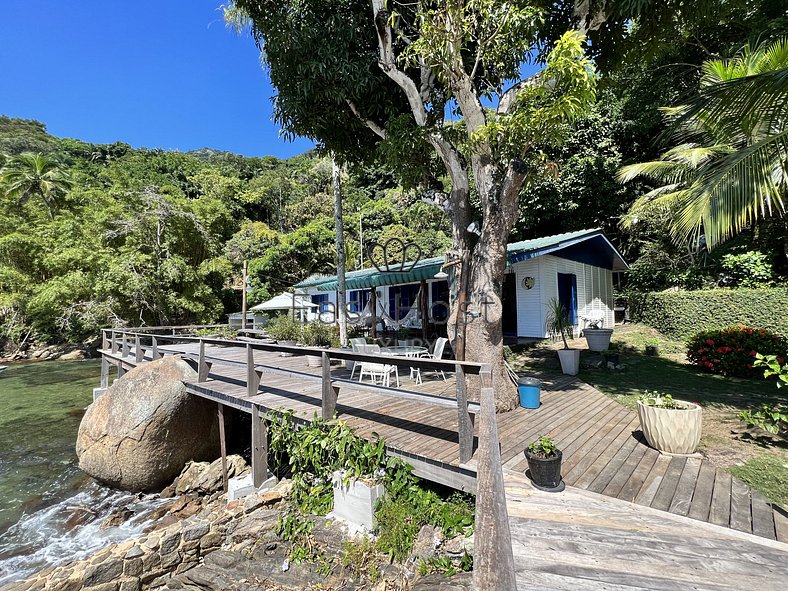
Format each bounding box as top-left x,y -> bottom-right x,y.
473,365 -> 517,591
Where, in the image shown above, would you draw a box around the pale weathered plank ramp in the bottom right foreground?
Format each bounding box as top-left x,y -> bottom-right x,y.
504,470 -> 788,591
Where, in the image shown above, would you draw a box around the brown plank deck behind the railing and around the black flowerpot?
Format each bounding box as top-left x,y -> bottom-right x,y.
103,343 -> 788,541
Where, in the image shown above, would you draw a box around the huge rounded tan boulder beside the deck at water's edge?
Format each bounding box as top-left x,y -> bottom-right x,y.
77,356 -> 219,491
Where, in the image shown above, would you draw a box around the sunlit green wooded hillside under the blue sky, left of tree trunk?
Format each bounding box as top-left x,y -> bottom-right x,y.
0,117 -> 456,352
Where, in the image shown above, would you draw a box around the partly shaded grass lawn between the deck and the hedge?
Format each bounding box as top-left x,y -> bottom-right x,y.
512,324 -> 788,506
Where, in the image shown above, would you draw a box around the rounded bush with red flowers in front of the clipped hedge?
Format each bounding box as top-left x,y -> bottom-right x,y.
687,324 -> 788,379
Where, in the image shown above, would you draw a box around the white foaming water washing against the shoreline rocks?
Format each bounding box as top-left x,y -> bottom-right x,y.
0,483 -> 166,585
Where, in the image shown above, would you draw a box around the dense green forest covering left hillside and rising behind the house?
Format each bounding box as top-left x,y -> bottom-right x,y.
0,0 -> 788,350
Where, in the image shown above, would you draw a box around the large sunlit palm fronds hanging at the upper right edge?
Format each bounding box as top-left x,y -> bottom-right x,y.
618,39 -> 788,248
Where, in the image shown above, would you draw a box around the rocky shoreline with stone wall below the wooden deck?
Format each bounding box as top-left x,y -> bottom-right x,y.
0,462 -> 472,591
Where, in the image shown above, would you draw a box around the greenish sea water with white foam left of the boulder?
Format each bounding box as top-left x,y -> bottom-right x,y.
0,360 -> 165,585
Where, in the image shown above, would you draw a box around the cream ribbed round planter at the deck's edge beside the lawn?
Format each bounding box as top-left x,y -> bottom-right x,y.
638,400 -> 703,454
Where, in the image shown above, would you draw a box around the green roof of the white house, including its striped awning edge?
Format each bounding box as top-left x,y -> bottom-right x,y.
295,229 -> 627,291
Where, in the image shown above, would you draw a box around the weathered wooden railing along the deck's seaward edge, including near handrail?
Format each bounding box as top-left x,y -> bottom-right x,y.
101,327 -> 516,591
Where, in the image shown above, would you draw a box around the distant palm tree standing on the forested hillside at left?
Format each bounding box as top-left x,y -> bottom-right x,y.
0,152 -> 71,219
